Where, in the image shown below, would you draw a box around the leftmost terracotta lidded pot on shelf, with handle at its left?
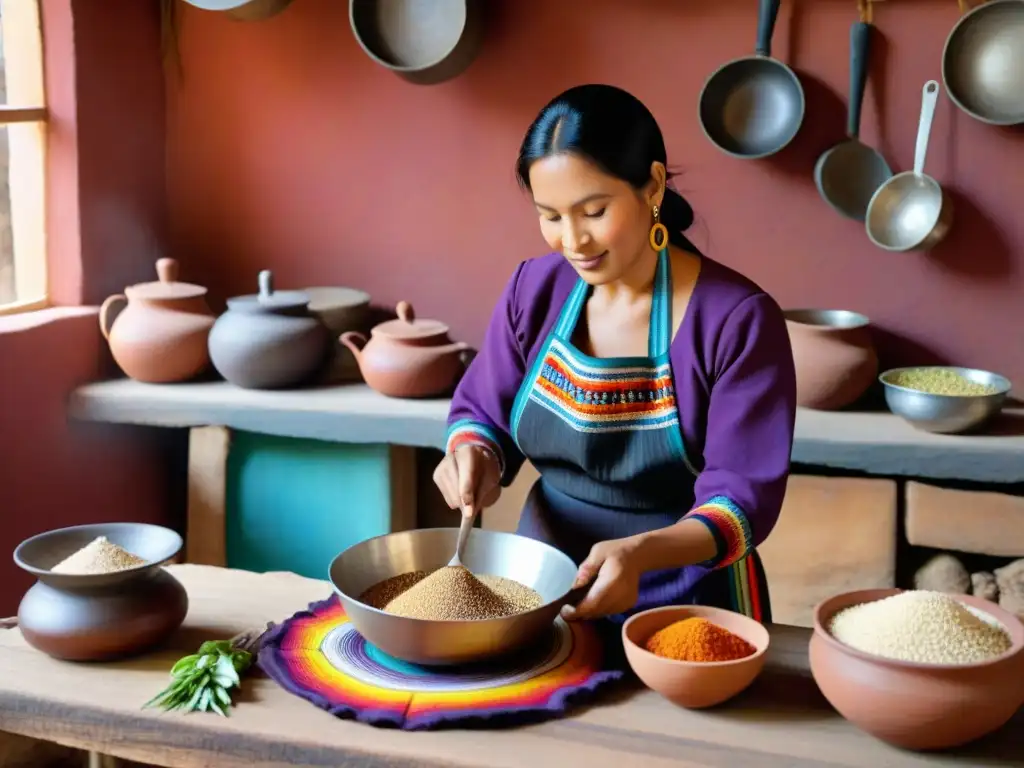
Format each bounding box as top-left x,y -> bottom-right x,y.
99,259 -> 214,384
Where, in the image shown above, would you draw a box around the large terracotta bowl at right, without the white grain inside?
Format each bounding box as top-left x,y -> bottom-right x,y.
810,589 -> 1024,751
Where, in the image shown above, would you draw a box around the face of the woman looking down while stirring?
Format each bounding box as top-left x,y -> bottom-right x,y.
529,154 -> 660,286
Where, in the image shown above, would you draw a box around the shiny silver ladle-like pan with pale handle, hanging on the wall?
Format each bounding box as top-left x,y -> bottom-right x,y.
864,80 -> 953,251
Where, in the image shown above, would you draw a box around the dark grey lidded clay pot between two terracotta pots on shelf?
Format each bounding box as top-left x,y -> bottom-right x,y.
210,269 -> 332,389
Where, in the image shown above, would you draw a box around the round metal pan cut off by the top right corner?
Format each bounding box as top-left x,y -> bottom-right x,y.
942,0 -> 1024,125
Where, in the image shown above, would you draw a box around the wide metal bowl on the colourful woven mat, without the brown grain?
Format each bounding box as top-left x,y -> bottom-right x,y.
330,528 -> 577,666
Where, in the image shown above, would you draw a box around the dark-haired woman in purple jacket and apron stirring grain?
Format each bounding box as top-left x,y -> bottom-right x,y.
434,85 -> 796,623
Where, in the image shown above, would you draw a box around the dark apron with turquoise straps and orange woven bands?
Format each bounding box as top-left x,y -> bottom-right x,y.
511,250 -> 771,623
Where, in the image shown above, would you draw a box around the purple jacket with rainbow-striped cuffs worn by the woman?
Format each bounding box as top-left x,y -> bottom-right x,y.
447,254 -> 796,567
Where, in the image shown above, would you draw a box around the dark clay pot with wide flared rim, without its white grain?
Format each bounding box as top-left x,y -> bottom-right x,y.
14,522 -> 188,662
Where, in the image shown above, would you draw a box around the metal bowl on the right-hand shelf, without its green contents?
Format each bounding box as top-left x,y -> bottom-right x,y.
879,366 -> 1012,434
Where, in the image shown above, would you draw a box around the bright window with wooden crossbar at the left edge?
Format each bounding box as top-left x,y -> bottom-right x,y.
0,0 -> 47,314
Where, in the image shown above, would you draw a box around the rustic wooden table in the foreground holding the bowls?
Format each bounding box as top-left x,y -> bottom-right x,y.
0,565 -> 1024,768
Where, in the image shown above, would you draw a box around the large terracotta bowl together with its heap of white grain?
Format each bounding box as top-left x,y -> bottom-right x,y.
810,589 -> 1024,750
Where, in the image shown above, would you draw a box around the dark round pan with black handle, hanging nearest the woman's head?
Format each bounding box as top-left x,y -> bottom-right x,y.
699,0 -> 805,160
